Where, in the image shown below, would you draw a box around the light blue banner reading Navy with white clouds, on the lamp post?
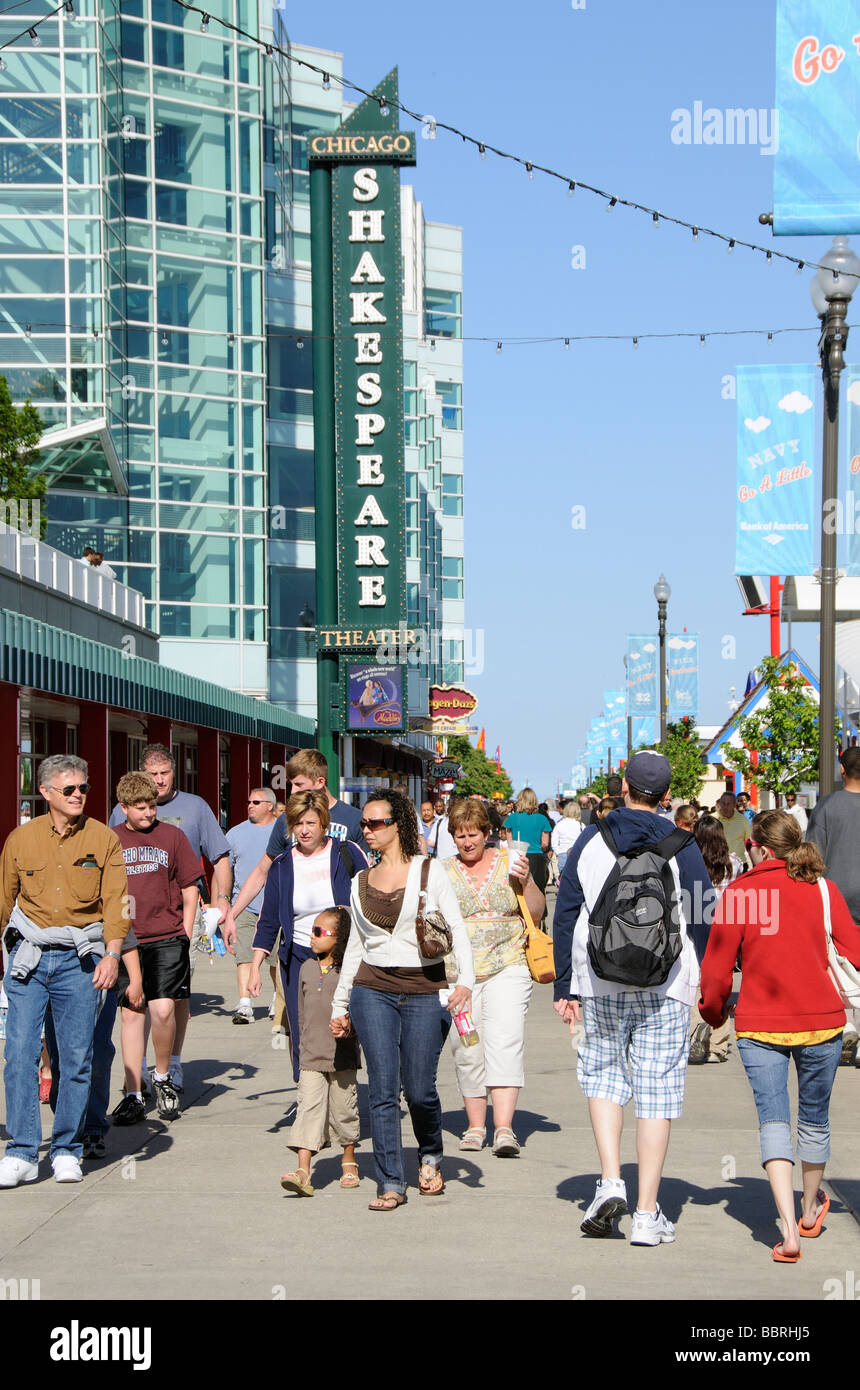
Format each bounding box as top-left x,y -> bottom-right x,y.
735,364 -> 816,574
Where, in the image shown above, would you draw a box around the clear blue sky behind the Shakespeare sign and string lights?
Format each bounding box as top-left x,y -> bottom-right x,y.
286,0 -> 853,795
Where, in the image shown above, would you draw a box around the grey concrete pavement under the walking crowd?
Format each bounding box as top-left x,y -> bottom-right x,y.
0,958 -> 860,1301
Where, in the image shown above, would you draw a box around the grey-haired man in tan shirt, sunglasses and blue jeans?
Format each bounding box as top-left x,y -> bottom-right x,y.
0,753 -> 129,1187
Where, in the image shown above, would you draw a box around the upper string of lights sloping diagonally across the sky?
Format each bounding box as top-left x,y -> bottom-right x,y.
163,0 -> 838,279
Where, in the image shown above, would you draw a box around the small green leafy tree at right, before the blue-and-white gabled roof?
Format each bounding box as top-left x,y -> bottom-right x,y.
722,656 -> 838,796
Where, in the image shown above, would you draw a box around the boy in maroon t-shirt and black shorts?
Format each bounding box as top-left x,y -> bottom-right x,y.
115,773 -> 200,1125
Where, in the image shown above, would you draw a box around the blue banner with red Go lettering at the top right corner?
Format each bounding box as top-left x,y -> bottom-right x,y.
778,0 -> 860,234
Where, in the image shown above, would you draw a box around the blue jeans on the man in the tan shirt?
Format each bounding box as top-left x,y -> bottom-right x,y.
4,949 -> 99,1163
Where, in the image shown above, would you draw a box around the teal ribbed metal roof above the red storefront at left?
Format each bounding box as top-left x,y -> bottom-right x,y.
0,613 -> 317,748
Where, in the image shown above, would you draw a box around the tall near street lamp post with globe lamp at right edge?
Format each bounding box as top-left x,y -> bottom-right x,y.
810,236 -> 860,796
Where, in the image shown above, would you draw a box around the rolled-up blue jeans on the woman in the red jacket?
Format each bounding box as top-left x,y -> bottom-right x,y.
738,1033 -> 842,1165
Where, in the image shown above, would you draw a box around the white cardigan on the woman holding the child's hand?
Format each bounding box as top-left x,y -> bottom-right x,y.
332,855 -> 475,1019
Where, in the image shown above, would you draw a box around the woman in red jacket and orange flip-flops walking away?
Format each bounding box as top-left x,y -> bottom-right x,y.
699,810 -> 860,1264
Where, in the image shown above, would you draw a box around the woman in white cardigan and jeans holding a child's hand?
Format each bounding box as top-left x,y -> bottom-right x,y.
331,791 -> 475,1212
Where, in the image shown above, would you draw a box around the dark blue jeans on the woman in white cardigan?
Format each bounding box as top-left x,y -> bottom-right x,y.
349,984 -> 450,1193
